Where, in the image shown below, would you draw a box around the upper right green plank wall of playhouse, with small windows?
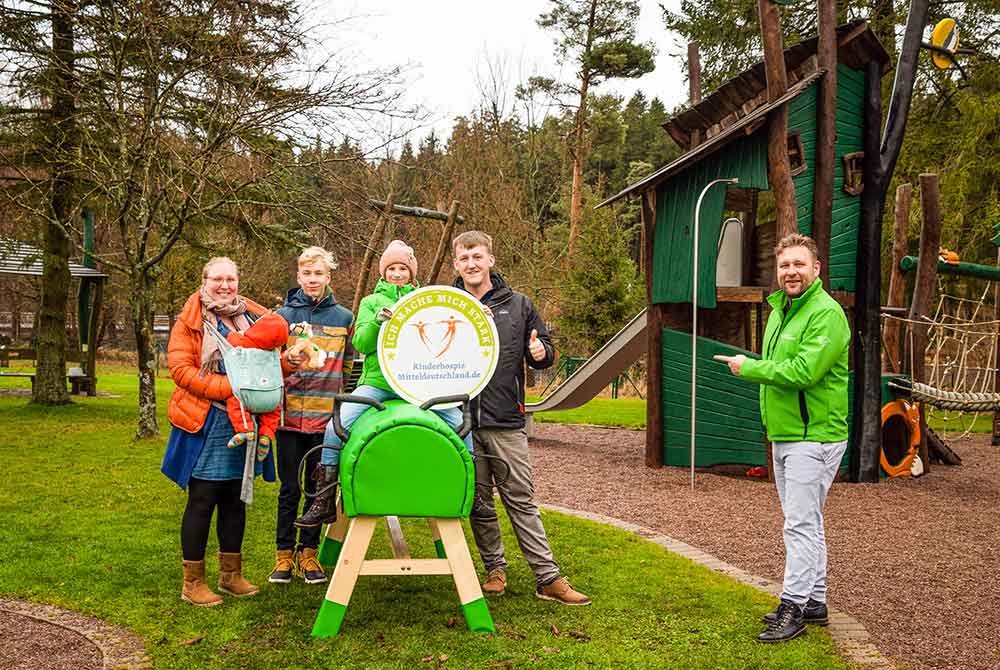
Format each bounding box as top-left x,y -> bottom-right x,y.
788,64 -> 865,292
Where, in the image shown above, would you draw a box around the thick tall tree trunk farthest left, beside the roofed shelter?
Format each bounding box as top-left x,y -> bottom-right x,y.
32,2 -> 78,405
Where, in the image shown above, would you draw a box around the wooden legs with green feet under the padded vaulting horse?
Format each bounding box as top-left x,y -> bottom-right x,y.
312,509 -> 496,637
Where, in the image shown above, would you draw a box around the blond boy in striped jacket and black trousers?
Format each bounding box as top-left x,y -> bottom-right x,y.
268,247 -> 354,584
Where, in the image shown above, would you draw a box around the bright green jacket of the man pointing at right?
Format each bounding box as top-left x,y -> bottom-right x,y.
740,278 -> 851,442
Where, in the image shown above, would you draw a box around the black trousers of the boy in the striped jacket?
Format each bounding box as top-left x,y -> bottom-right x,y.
275,430 -> 323,550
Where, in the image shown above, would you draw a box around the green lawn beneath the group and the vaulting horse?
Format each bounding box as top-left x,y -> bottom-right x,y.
0,372 -> 847,670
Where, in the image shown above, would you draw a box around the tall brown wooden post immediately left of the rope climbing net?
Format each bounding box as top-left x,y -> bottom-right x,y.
906,174 -> 941,472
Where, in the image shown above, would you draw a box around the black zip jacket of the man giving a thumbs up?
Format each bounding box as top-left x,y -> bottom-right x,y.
454,272 -> 556,428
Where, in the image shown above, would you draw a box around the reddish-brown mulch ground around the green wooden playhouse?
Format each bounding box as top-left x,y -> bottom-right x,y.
531,424 -> 1000,670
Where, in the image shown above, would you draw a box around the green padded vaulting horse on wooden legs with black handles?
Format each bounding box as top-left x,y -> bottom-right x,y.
312,395 -> 496,637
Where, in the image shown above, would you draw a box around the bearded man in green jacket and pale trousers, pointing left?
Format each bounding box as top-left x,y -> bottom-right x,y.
715,233 -> 851,642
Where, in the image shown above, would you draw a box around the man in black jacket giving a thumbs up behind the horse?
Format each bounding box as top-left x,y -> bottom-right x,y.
452,231 -> 590,605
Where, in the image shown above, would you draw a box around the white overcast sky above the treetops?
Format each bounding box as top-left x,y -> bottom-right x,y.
310,0 -> 687,150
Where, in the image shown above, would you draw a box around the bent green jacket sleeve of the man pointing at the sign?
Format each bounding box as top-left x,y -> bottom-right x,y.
740,309 -> 851,390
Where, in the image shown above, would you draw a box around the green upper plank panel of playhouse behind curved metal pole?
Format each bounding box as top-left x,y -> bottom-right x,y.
653,132 -> 767,308
